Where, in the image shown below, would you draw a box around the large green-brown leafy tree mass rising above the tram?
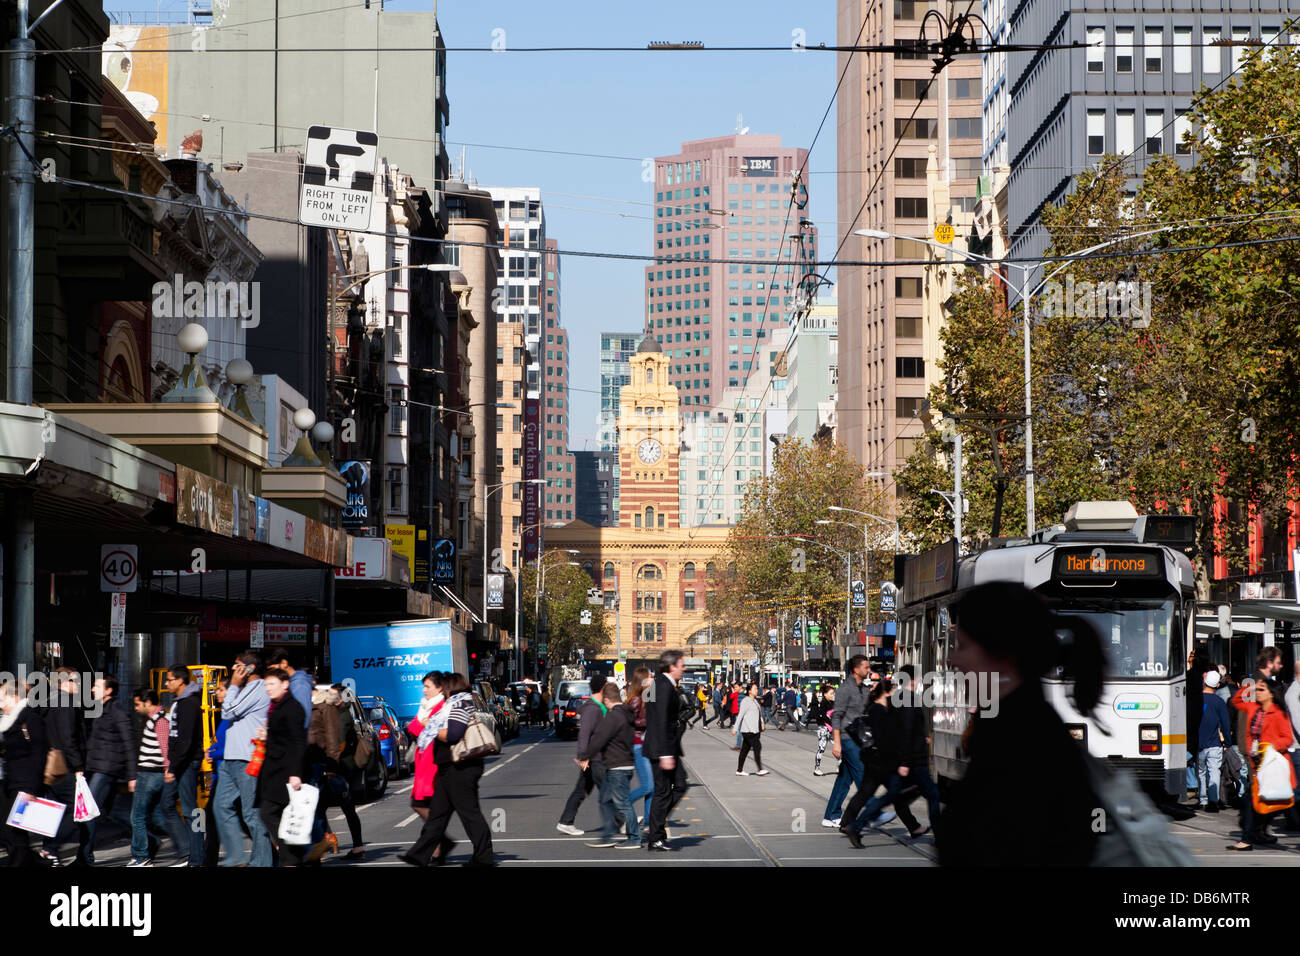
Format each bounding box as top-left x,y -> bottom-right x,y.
898,47 -> 1300,597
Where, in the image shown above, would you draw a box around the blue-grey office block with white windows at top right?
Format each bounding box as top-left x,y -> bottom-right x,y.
1006,6 -> 1294,265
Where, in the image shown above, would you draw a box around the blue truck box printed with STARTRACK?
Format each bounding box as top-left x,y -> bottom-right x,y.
329,618 -> 469,722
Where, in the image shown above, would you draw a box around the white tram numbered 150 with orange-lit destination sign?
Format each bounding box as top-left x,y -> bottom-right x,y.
897,502 -> 1196,793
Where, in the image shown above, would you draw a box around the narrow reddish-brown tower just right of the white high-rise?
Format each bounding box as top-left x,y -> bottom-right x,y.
537,239 -> 577,524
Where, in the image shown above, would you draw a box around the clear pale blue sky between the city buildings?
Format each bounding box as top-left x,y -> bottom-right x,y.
105,0 -> 837,450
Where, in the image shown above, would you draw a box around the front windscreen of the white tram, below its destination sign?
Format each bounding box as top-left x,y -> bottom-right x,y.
1053,597 -> 1184,679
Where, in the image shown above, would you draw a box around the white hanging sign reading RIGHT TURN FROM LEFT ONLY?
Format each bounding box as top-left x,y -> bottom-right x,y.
298,126 -> 380,229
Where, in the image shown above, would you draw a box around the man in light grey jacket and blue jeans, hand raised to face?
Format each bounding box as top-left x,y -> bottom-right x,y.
213,652 -> 270,866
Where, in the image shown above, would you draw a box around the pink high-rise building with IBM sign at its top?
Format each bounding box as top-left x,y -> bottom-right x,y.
645,135 -> 816,411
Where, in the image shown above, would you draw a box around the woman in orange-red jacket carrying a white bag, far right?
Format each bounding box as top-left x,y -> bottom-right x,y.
1229,680 -> 1296,851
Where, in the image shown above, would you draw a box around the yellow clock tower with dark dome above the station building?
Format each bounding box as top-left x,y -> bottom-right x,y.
619,336 -> 681,531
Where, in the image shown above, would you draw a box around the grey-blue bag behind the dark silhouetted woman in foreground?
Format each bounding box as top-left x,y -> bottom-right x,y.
1083,754 -> 1196,866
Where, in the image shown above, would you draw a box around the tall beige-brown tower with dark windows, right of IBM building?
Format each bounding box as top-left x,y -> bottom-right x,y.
836,0 -> 977,472
